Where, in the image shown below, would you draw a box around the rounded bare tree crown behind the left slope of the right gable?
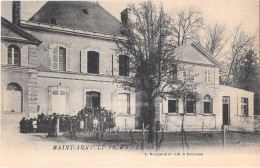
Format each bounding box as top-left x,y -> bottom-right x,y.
172,7 -> 203,46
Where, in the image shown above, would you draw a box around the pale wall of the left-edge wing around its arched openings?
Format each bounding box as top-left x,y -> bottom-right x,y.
1,41 -> 37,117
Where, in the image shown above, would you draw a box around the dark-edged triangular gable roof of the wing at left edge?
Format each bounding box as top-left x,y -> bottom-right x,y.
1,17 -> 41,45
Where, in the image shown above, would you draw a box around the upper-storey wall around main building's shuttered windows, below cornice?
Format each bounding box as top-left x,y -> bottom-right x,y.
27,30 -> 115,75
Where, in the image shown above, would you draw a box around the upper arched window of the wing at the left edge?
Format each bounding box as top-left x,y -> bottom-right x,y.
8,45 -> 21,66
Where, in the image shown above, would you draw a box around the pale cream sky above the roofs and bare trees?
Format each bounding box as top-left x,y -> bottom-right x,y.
1,0 -> 260,55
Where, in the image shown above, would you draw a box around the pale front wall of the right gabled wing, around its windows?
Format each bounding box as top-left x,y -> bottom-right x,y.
157,58 -> 221,131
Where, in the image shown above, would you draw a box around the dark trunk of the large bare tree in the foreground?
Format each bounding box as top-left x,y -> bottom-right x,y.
148,100 -> 155,144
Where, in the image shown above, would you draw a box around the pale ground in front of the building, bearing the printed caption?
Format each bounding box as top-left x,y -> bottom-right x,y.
1,117 -> 260,167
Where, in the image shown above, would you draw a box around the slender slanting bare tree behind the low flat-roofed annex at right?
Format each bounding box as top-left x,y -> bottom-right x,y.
225,24 -> 255,85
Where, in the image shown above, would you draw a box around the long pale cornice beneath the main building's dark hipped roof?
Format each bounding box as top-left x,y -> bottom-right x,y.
20,20 -> 123,40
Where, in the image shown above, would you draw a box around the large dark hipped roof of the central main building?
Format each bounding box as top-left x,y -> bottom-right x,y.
29,1 -> 121,35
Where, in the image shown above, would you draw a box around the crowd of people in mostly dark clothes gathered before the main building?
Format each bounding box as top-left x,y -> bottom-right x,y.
20,107 -> 116,137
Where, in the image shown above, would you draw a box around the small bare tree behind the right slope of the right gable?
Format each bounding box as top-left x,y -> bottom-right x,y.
204,24 -> 226,59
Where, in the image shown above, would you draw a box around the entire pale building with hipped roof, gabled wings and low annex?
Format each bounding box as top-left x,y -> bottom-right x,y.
1,1 -> 254,131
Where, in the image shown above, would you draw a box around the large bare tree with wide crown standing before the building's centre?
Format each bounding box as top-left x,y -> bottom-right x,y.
113,1 -> 196,143
